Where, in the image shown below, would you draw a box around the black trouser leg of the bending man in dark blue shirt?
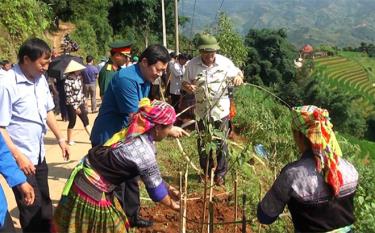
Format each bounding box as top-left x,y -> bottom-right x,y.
115,176 -> 141,223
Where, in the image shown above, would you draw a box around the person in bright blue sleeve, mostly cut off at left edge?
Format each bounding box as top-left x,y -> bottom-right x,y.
0,134 -> 35,233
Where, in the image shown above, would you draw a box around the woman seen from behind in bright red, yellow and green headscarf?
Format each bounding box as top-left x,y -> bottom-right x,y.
257,106 -> 358,233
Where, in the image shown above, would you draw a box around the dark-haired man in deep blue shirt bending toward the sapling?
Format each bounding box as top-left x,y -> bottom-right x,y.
90,45 -> 186,227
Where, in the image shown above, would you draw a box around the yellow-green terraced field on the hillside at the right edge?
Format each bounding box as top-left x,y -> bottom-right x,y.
314,56 -> 375,113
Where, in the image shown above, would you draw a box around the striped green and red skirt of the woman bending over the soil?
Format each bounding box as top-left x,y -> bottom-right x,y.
51,158 -> 130,233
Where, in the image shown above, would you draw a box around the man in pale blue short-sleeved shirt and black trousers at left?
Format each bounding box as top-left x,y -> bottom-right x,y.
0,38 -> 69,232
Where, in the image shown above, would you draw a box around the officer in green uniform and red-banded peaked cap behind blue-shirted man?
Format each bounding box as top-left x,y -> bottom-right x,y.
98,40 -> 131,99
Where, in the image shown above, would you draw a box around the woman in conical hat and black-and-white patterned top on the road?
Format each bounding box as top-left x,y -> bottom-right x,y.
64,60 -> 91,146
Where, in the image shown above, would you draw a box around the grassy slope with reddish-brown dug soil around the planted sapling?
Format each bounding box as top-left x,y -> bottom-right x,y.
136,86 -> 375,233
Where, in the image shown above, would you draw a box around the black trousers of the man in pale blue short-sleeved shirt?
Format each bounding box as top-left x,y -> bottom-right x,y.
13,160 -> 52,232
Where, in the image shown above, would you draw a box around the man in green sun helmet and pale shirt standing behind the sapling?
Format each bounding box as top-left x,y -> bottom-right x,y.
182,34 -> 243,185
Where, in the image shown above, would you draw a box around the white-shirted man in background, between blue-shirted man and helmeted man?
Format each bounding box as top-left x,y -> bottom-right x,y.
169,53 -> 188,113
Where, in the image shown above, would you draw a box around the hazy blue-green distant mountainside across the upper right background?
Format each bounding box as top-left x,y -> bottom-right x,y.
180,0 -> 375,47
